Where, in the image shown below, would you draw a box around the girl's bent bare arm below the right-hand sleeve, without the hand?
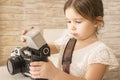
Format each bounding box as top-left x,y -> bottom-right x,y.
53,64 -> 107,80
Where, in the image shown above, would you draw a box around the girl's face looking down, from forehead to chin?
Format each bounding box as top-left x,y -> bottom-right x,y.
65,8 -> 97,40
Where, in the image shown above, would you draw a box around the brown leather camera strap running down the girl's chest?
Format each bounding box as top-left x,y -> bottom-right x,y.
62,38 -> 76,74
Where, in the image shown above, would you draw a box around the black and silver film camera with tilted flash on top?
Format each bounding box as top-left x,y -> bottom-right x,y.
7,29 -> 50,80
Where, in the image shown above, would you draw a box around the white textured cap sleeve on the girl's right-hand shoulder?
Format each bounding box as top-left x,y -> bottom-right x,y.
88,41 -> 119,69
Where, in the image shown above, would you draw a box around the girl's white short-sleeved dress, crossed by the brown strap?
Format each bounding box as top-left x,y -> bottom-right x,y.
54,35 -> 119,77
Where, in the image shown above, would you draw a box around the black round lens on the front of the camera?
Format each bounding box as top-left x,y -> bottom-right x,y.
7,56 -> 25,75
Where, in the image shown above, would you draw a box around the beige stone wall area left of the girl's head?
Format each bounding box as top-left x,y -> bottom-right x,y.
0,0 -> 65,65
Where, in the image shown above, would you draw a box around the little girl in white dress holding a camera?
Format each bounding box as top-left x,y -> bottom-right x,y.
22,0 -> 118,80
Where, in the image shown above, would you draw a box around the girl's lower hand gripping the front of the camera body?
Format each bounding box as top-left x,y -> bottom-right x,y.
30,61 -> 59,80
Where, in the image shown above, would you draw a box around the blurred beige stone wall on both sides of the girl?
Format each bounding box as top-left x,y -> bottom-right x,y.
0,0 -> 120,80
